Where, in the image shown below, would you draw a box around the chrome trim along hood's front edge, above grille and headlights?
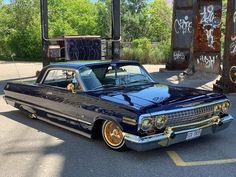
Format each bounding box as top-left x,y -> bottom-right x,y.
138,99 -> 229,130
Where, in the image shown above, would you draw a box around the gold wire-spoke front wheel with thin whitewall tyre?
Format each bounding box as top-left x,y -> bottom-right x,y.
102,120 -> 125,150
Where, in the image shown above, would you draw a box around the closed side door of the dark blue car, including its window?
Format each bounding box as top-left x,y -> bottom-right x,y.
41,68 -> 96,131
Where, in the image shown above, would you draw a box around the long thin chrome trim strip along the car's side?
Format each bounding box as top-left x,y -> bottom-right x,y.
6,97 -> 92,125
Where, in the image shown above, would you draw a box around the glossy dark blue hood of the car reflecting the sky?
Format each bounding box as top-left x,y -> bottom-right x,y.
88,84 -> 225,110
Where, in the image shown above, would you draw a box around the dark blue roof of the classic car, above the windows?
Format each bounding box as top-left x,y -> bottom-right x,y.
49,60 -> 138,69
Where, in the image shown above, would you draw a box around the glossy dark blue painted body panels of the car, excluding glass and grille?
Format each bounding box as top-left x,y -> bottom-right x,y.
4,61 -> 226,138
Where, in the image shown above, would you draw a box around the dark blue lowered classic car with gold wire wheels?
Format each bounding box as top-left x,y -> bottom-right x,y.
4,61 -> 233,151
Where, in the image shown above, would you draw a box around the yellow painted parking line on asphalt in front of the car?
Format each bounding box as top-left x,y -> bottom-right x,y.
167,151 -> 236,167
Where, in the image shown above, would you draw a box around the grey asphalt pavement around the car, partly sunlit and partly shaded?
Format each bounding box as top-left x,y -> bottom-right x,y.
0,62 -> 236,177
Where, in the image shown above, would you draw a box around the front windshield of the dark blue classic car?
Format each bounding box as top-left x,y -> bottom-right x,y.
79,64 -> 153,90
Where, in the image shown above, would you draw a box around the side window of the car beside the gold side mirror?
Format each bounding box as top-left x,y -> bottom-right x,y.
43,69 -> 79,88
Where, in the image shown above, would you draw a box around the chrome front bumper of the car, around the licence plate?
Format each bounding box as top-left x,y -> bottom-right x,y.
125,115 -> 234,151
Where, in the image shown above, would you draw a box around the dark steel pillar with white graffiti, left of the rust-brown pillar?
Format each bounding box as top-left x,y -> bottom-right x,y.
167,0 -> 194,70
